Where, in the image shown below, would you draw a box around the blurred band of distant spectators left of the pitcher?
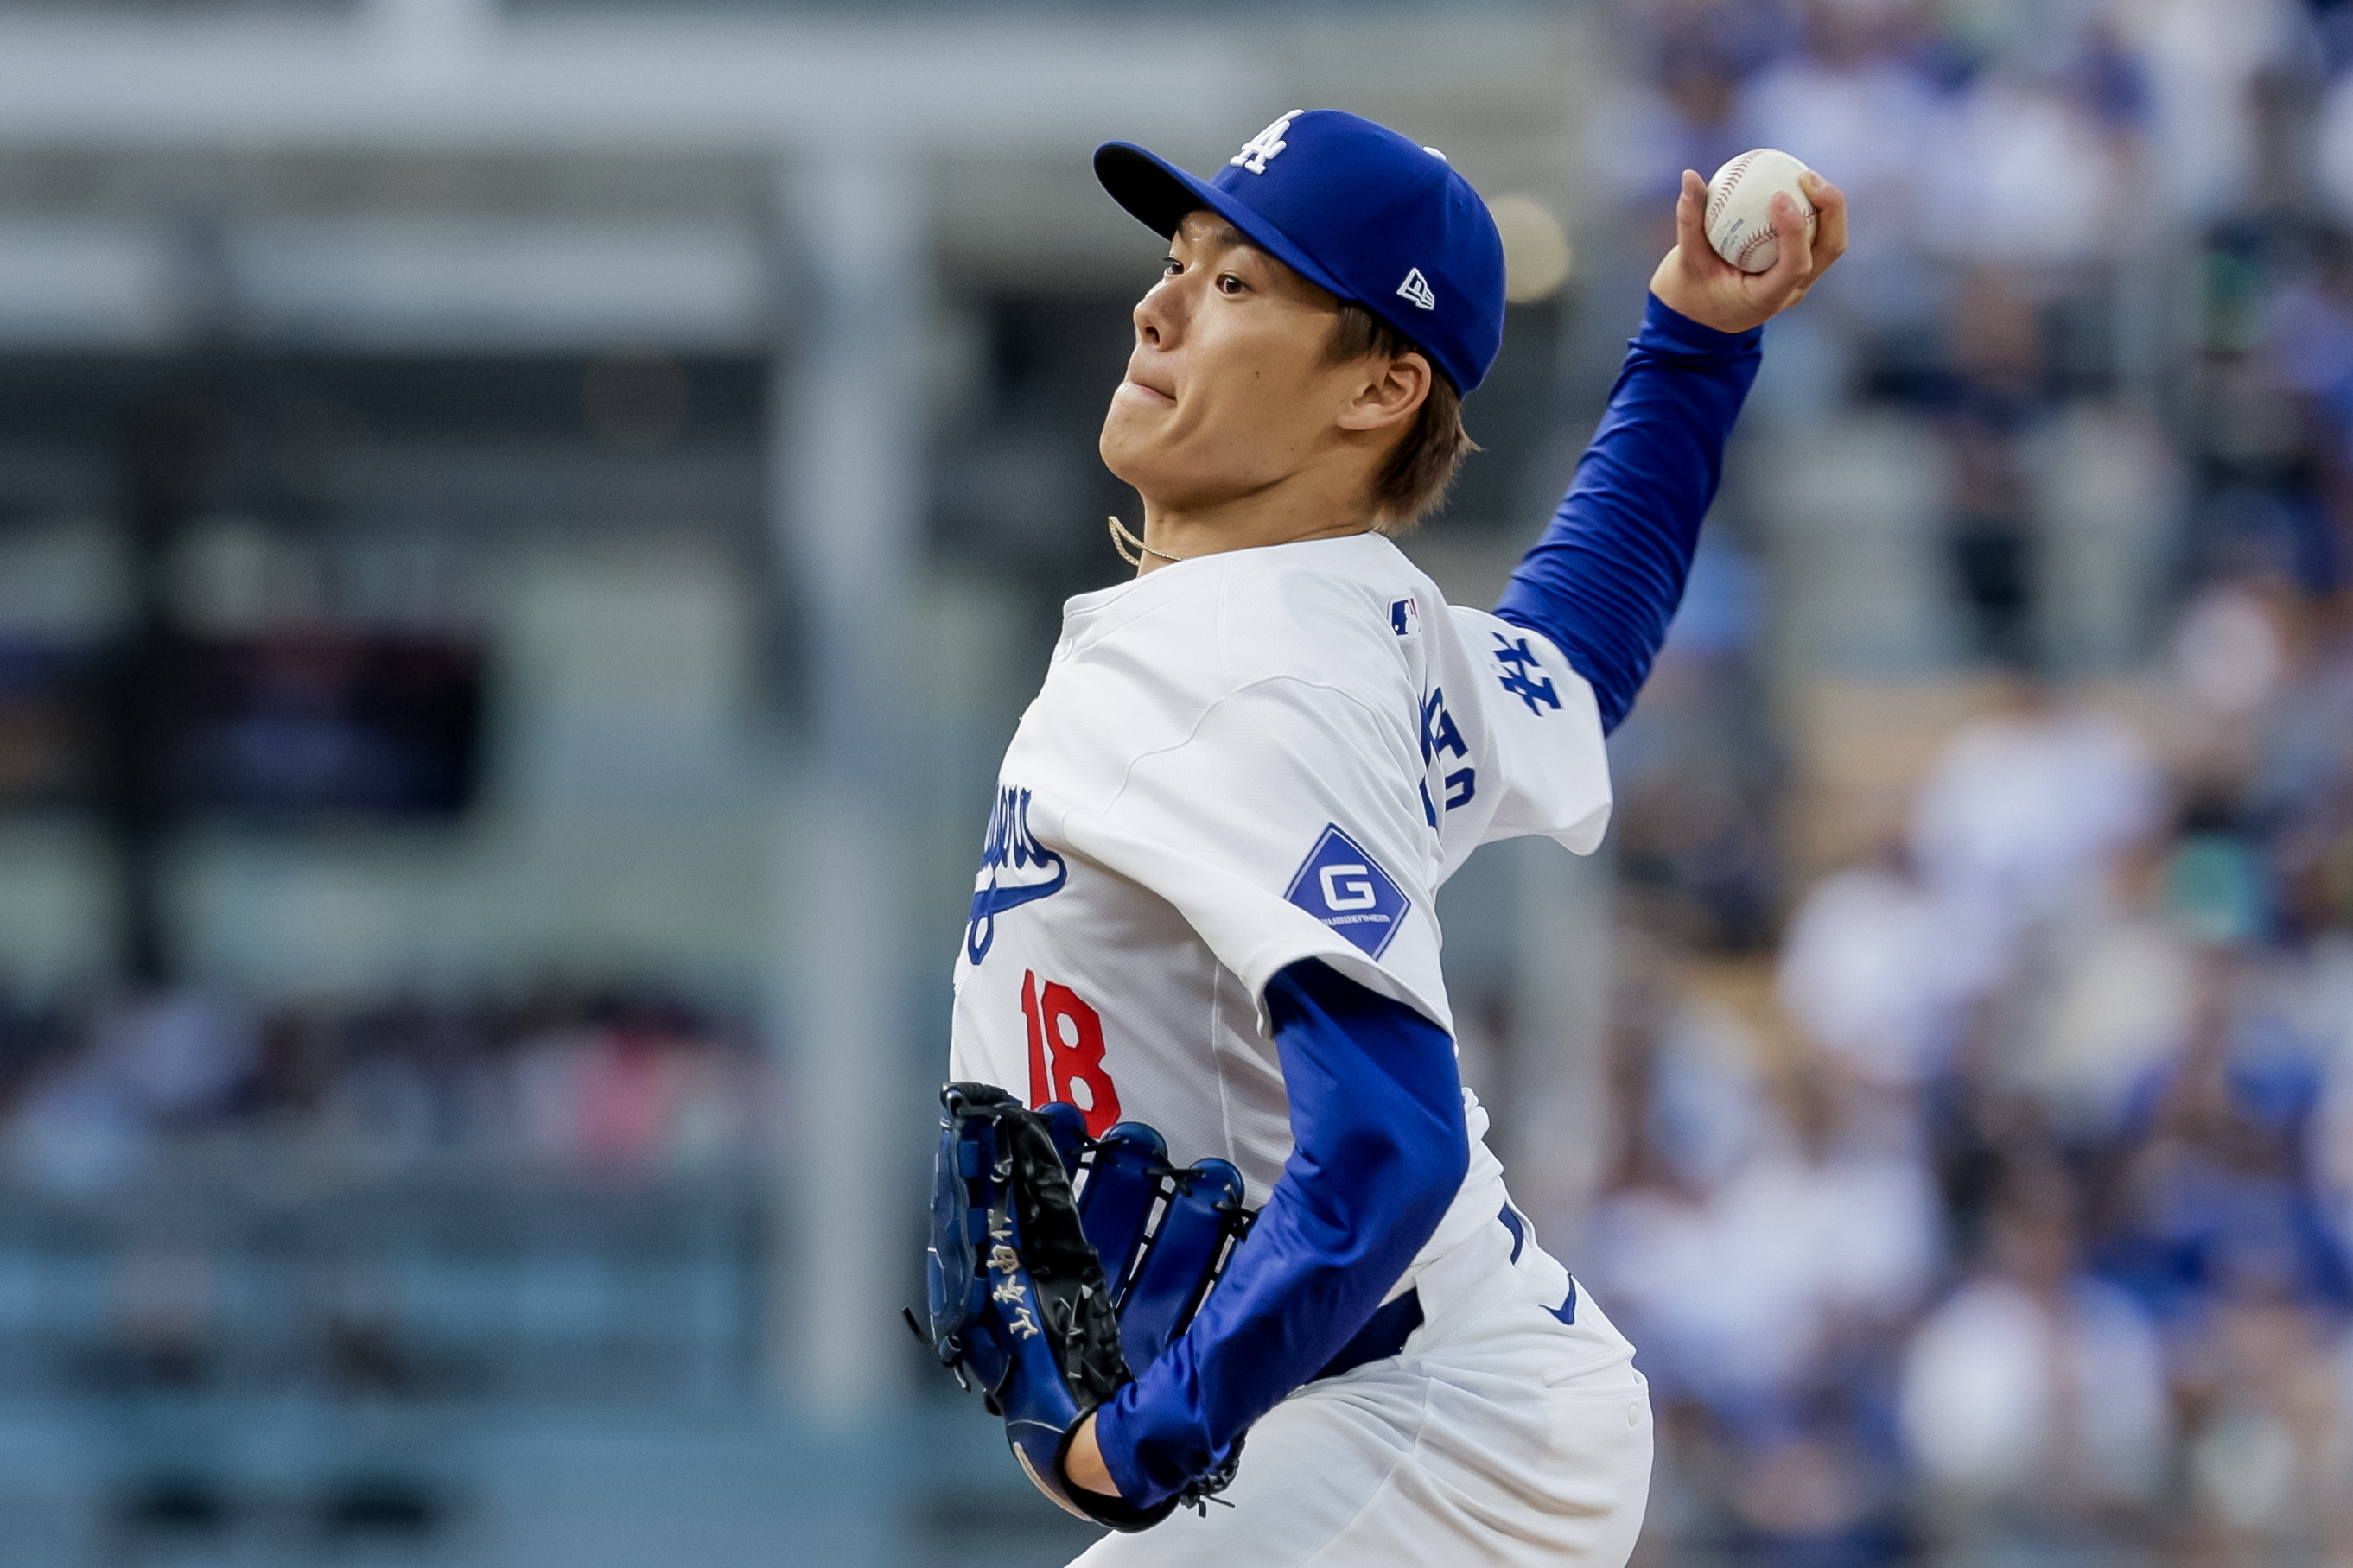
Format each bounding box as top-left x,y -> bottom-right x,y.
0,987 -> 762,1197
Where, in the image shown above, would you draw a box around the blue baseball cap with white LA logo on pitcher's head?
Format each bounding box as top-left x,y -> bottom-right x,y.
1094,108 -> 1504,392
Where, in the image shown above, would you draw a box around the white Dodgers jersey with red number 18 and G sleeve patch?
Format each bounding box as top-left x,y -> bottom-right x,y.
951,534 -> 1610,1288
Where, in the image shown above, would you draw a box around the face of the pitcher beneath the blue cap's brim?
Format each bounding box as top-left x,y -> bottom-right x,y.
1099,212 -> 1363,510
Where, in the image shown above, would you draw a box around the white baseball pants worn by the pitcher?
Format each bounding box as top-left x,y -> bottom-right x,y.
1073,1225 -> 1650,1568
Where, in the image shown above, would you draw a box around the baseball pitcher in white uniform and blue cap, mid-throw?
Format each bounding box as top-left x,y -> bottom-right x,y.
925,111 -> 1847,1568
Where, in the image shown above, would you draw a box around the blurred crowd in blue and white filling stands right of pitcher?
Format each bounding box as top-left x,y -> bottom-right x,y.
1579,0 -> 2353,1564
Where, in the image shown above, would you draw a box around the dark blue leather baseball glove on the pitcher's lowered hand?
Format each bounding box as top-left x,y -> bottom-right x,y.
908,1083 -> 1252,1530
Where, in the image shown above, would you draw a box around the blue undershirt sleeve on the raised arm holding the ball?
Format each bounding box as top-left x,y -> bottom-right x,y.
1494,296 -> 1765,733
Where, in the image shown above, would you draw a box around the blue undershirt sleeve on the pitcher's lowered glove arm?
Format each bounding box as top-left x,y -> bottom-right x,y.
1094,959 -> 1471,1507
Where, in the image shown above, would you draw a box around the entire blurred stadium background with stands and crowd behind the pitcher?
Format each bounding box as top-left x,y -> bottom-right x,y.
0,0 -> 2353,1568
